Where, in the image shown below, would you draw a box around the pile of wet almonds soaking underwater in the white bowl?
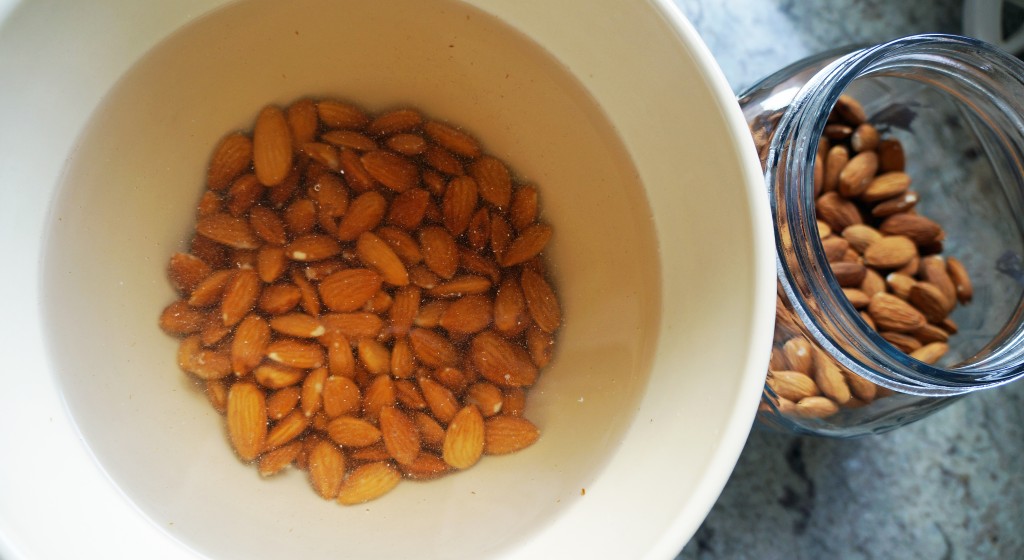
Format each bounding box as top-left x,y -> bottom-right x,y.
160,99 -> 561,505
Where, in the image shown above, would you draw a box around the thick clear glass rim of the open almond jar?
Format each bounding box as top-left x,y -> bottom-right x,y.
766,35 -> 1024,396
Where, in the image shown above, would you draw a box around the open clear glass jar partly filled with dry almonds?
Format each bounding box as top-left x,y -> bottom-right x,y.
739,35 -> 1024,437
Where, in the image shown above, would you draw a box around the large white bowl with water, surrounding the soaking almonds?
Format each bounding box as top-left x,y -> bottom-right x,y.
0,0 -> 774,559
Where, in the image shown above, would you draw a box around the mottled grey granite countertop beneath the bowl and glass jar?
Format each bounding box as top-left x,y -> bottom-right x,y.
675,0 -> 1024,560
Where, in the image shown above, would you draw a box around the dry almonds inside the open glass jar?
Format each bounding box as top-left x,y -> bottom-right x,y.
768,95 -> 973,418
